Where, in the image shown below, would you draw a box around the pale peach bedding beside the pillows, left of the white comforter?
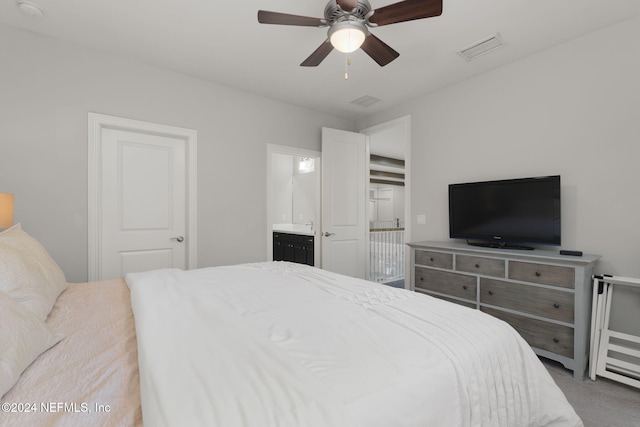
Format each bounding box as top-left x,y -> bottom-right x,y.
0,279 -> 142,427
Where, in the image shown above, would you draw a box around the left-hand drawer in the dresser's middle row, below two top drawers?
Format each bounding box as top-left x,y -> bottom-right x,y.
415,267 -> 477,301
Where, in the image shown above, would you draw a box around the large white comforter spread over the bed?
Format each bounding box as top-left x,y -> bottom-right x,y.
125,262 -> 582,427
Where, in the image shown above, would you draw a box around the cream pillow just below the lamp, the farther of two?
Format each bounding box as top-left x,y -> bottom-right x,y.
0,224 -> 69,320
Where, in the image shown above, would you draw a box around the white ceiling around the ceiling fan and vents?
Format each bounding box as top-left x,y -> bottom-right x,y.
0,0 -> 640,119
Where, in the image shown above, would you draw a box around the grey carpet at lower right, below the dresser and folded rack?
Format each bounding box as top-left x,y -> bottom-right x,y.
541,359 -> 640,427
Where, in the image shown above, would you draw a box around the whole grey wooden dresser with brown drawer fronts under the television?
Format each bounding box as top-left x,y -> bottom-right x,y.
409,242 -> 599,379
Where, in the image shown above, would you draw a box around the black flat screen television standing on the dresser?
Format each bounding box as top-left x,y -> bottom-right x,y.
449,175 -> 560,249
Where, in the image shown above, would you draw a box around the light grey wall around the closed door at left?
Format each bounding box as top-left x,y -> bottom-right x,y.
0,25 -> 354,281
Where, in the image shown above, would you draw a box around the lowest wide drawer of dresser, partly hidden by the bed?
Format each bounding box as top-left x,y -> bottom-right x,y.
480,307 -> 574,359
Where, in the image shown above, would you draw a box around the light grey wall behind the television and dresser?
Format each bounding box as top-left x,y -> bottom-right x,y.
358,17 -> 640,334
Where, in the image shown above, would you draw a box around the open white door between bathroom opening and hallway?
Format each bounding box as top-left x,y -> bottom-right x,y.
320,128 -> 368,279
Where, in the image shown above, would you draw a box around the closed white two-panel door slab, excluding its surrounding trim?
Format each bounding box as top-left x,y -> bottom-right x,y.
99,128 -> 188,279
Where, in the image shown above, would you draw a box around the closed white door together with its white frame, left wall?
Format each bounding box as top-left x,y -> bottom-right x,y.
88,113 -> 197,281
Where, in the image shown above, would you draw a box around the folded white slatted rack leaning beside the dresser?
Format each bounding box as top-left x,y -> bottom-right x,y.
589,275 -> 640,388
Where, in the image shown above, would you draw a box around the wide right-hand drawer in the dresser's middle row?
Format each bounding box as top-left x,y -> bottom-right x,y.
480,277 -> 574,323
